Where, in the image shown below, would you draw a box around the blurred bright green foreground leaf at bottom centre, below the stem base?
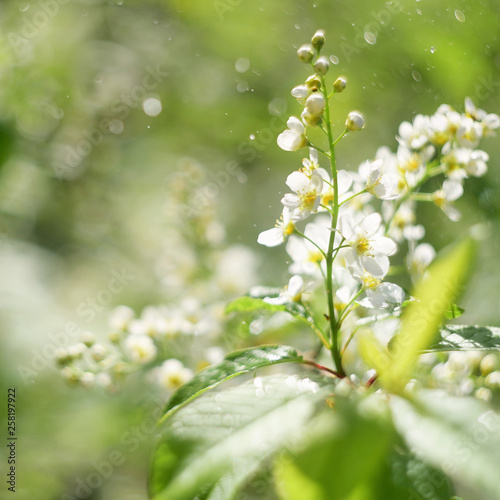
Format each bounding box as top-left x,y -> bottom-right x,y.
276,398 -> 401,500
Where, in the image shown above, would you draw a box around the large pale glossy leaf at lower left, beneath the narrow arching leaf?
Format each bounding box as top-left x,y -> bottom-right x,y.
150,375 -> 333,500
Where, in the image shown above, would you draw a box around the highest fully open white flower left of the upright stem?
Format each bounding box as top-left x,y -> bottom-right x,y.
281,170 -> 323,219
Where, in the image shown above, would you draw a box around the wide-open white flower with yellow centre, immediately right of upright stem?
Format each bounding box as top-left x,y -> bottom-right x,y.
338,213 -> 397,274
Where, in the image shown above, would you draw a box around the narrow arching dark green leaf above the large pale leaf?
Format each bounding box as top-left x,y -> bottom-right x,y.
158,345 -> 302,420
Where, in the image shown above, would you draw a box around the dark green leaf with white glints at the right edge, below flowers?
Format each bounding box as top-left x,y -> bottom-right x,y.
426,325 -> 500,352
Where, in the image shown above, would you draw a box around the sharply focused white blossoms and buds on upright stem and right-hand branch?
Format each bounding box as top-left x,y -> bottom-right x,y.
258,32 -> 500,348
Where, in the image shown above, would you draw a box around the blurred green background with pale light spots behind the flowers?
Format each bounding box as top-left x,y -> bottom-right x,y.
0,0 -> 500,500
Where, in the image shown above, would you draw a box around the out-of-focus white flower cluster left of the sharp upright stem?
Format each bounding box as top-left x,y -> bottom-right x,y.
58,159 -> 257,391
